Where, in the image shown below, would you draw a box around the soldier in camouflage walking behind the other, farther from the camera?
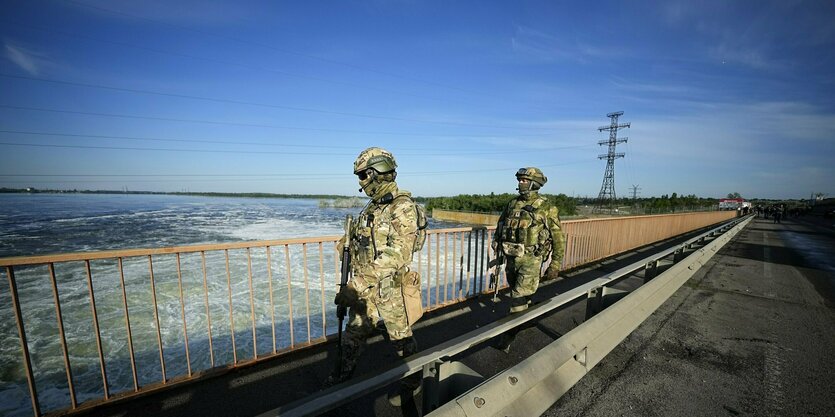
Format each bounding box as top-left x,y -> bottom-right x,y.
492,167 -> 565,352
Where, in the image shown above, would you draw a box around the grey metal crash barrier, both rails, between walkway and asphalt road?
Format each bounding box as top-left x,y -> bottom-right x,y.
272,216 -> 751,417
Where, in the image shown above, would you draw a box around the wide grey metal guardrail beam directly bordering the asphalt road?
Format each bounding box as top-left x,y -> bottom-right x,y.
428,216 -> 752,417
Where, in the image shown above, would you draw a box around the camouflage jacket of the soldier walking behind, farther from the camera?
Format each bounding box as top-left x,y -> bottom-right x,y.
493,192 -> 565,265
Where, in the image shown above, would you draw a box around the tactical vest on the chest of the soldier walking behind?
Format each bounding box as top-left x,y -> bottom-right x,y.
499,197 -> 551,256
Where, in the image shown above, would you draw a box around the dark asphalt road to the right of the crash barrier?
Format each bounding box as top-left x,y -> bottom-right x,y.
545,214 -> 835,416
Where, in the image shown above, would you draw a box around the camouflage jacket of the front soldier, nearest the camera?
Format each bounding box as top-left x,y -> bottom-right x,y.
350,183 -> 418,287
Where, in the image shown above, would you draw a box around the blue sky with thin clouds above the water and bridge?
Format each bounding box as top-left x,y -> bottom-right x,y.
0,0 -> 835,198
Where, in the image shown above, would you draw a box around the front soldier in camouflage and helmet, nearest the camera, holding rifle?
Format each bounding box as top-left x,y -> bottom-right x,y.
326,148 -> 421,405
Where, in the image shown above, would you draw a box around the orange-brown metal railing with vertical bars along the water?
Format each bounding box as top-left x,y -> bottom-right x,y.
0,212 -> 734,416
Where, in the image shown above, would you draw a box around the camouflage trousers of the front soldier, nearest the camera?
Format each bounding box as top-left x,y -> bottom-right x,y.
333,279 -> 417,382
